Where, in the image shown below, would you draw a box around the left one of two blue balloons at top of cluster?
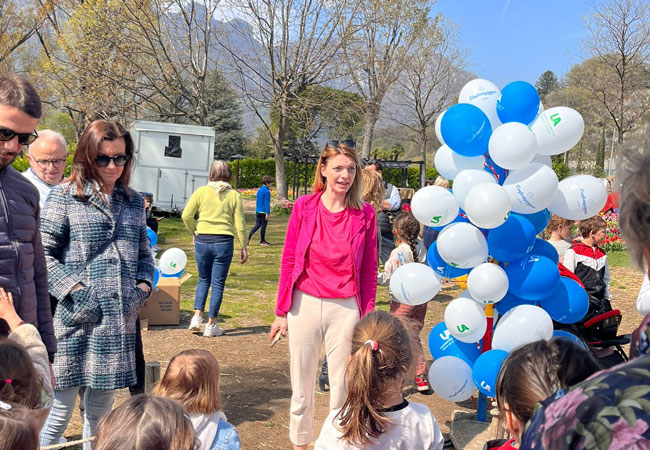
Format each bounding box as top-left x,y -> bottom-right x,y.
440,103 -> 492,156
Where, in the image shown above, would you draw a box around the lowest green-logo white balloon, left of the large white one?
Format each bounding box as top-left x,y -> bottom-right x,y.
445,297 -> 487,343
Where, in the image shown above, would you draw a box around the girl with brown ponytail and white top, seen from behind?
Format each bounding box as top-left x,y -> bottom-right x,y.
315,311 -> 444,450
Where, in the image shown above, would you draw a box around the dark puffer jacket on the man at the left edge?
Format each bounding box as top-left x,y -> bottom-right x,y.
0,167 -> 56,355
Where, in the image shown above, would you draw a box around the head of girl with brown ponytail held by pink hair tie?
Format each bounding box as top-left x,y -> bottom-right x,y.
339,311 -> 414,447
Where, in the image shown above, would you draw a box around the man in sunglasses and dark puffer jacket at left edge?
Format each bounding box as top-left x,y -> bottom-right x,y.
0,75 -> 56,360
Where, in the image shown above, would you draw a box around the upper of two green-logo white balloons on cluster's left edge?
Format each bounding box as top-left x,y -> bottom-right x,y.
411,186 -> 458,227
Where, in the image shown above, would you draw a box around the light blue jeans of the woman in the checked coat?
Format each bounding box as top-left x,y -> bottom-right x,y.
41,387 -> 115,450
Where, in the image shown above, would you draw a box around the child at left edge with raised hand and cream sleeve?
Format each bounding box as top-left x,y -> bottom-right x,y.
0,288 -> 54,433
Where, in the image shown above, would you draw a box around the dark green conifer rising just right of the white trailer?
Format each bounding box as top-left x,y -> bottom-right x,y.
206,70 -> 244,159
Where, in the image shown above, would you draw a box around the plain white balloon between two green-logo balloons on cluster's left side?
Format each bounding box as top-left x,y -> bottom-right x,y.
436,222 -> 488,269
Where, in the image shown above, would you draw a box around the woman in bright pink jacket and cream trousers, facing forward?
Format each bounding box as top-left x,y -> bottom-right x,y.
269,141 -> 377,450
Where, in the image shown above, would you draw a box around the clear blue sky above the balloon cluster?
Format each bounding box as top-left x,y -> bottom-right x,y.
434,0 -> 591,88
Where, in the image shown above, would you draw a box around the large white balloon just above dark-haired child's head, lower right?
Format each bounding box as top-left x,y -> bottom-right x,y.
492,305 -> 553,352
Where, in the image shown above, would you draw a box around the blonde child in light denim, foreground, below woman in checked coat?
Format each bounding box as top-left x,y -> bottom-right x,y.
153,350 -> 241,450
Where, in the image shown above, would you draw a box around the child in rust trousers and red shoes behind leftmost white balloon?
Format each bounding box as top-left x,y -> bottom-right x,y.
377,212 -> 433,395
